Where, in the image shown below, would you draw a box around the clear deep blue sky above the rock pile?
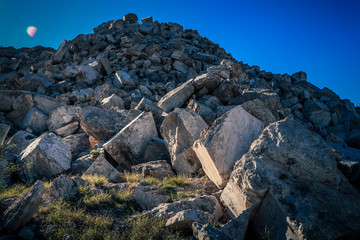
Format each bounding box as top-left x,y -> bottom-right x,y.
0,0 -> 360,106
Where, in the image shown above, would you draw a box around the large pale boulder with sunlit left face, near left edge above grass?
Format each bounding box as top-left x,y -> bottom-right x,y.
16,133 -> 71,183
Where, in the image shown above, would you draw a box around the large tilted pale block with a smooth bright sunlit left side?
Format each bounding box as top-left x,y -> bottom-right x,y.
194,106 -> 264,188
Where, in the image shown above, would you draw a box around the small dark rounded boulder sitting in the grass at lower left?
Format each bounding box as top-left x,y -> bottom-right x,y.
45,175 -> 79,201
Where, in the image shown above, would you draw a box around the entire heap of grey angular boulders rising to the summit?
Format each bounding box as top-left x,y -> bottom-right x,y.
0,14 -> 360,240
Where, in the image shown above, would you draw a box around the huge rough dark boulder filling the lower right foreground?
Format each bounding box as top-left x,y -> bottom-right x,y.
221,118 -> 360,239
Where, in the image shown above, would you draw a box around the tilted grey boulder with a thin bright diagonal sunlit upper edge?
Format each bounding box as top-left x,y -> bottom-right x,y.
103,112 -> 157,167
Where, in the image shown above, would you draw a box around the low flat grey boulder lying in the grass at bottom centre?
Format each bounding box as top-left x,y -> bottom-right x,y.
146,196 -> 223,227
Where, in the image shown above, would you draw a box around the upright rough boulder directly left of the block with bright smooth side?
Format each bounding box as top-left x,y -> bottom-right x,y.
160,108 -> 207,174
